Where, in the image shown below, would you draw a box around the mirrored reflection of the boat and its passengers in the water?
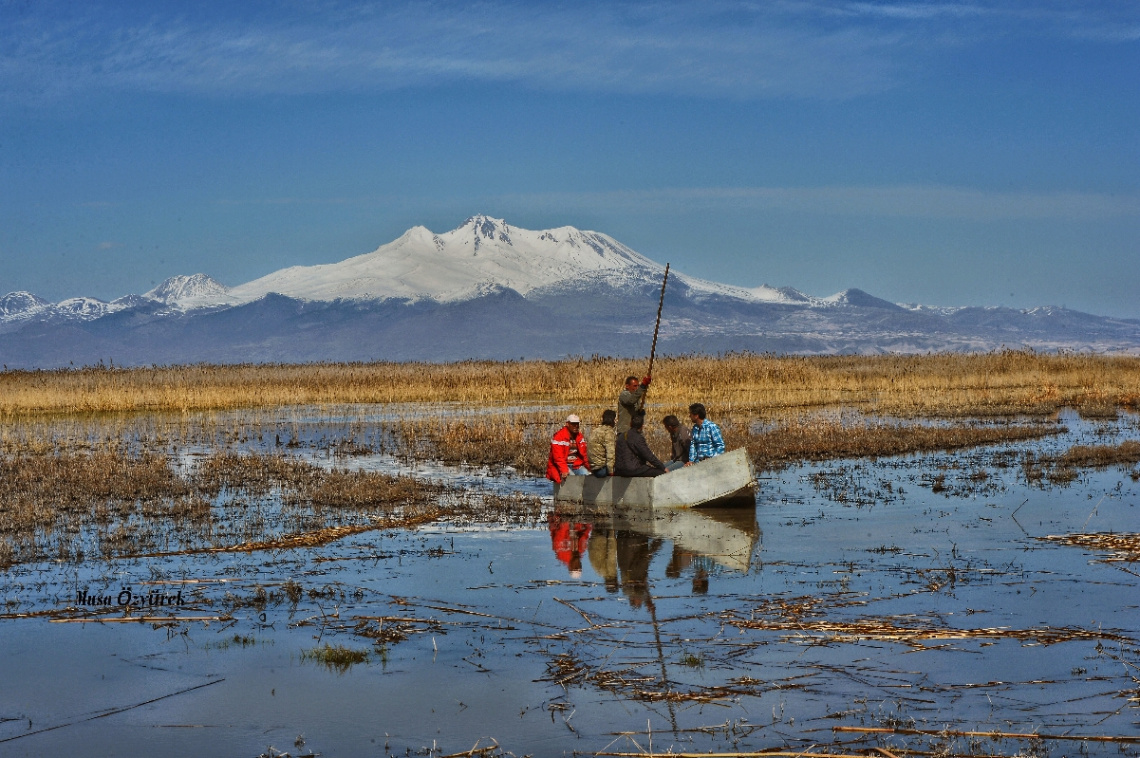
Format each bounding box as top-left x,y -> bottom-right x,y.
549,503 -> 763,606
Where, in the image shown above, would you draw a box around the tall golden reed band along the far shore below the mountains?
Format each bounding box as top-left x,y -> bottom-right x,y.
0,351 -> 1140,417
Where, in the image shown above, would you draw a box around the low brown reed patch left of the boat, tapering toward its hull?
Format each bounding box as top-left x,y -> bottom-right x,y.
0,443 -> 540,569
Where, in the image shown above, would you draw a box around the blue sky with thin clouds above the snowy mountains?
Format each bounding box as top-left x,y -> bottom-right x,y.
0,0 -> 1140,318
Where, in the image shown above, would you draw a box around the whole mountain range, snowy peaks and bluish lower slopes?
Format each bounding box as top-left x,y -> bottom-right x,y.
0,215 -> 1140,368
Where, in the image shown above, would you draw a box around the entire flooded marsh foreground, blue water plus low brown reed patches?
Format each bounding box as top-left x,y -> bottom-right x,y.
0,392 -> 1140,758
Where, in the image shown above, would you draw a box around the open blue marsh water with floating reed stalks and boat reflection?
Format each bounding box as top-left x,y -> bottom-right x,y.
0,415 -> 1140,756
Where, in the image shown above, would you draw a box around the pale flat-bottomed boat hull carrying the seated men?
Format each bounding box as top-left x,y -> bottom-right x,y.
554,448 -> 756,508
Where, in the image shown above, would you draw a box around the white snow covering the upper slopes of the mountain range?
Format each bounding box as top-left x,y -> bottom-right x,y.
0,215 -> 934,321
